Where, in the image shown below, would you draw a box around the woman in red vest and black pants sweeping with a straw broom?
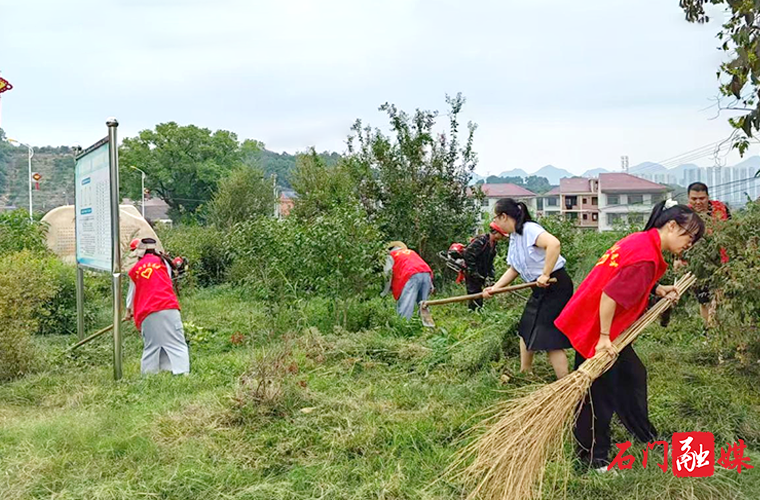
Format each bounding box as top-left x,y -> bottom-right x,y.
555,200 -> 705,472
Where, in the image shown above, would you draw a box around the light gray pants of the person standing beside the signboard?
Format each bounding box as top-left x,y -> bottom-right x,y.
141,309 -> 190,375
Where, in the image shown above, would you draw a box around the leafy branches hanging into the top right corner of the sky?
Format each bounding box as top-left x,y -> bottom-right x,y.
680,0 -> 760,154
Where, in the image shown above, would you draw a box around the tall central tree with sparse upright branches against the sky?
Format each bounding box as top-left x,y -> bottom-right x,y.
347,94 -> 480,263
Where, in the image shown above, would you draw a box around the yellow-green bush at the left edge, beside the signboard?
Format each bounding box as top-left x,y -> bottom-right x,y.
0,250 -> 57,380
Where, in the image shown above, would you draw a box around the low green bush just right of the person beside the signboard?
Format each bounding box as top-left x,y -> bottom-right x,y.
156,225 -> 231,287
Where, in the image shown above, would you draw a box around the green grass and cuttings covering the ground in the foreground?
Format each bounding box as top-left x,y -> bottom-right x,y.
0,289 -> 760,500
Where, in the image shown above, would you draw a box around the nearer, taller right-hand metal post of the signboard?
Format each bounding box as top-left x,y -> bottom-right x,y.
106,118 -> 122,380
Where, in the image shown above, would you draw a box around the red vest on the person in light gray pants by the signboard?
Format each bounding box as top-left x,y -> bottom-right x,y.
129,254 -> 179,330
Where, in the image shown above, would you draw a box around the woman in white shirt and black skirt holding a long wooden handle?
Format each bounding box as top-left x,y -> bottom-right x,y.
483,198 -> 573,379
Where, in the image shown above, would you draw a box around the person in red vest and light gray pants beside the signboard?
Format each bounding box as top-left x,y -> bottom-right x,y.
127,238 -> 190,375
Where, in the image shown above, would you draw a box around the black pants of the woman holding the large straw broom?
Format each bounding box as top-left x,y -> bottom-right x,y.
573,345 -> 657,467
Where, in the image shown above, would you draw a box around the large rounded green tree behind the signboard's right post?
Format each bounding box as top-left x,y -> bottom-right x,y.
119,122 -> 242,219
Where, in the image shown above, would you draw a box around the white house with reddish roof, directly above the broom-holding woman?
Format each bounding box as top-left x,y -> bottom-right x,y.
598,172 -> 669,231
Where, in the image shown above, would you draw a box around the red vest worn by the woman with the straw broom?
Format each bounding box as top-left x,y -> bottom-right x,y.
554,229 -> 668,359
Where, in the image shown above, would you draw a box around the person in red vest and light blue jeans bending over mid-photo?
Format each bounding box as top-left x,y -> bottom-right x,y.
381,241 -> 435,319
